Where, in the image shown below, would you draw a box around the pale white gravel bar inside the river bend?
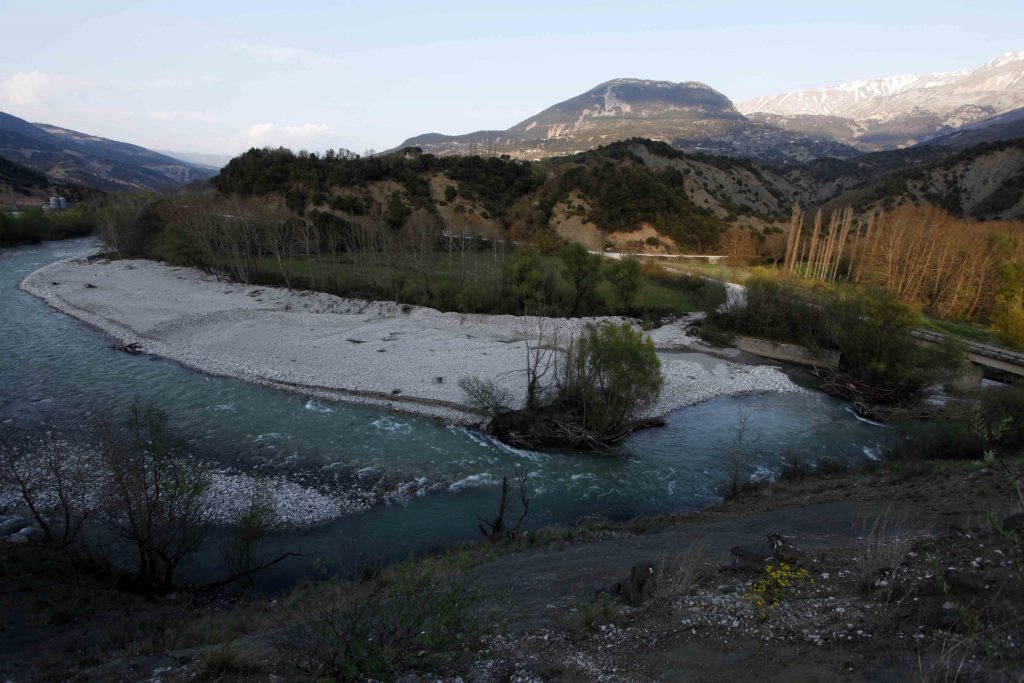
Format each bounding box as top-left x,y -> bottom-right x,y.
14,257 -> 801,424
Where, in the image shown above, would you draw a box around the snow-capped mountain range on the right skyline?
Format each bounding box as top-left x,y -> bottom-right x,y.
737,51 -> 1024,151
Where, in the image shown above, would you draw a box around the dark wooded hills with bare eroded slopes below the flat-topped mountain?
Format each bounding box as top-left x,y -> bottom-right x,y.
212,139 -> 1020,251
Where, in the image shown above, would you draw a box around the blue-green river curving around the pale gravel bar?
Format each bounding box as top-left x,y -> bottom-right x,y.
0,240 -> 887,585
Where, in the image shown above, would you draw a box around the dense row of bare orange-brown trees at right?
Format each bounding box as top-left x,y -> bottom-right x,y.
782,206 -> 1024,346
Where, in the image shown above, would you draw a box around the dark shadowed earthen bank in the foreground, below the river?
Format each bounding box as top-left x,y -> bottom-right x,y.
0,460 -> 1024,683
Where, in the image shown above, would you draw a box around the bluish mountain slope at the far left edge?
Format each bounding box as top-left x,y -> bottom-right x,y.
0,112 -> 215,190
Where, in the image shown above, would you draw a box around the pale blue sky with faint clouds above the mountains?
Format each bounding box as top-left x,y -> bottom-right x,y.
0,0 -> 1024,155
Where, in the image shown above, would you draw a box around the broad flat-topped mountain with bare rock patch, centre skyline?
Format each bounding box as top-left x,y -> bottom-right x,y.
400,79 -> 857,162
